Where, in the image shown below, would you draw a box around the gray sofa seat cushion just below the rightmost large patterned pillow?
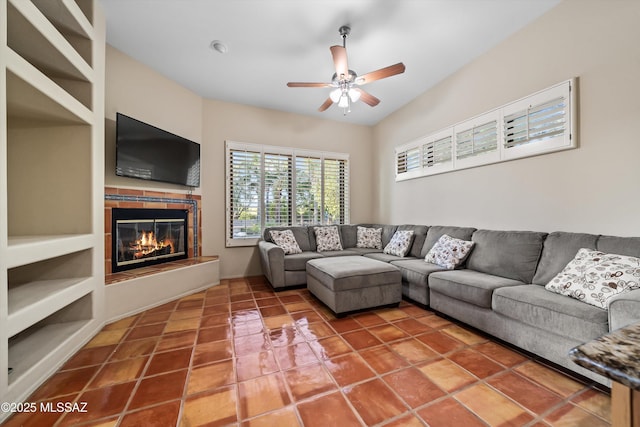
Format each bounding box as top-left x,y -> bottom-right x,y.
492,285 -> 609,341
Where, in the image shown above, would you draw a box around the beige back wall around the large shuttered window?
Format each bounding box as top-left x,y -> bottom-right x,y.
202,100 -> 374,277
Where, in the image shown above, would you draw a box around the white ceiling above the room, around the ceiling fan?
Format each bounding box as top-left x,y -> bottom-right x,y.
101,0 -> 560,125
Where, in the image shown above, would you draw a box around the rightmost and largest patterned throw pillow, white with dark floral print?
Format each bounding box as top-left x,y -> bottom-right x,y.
545,248 -> 640,310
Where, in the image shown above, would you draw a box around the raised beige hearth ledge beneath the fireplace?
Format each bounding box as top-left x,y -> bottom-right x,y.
105,256 -> 220,323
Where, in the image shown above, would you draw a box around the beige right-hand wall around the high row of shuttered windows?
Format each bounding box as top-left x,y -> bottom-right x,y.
374,0 -> 640,236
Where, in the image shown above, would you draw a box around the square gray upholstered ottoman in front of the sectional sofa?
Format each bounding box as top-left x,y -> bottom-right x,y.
307,256 -> 402,315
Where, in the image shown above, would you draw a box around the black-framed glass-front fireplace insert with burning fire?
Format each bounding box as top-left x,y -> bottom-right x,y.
111,208 -> 189,273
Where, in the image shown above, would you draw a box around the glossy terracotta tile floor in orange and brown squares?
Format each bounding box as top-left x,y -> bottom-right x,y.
6,278 -> 611,427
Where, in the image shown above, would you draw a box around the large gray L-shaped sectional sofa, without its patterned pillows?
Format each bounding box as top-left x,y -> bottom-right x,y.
258,224 -> 640,385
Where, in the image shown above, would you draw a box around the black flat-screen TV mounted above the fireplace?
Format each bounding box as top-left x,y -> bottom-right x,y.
116,113 -> 200,187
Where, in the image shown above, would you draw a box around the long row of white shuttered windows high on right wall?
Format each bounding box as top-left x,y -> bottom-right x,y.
395,79 -> 577,181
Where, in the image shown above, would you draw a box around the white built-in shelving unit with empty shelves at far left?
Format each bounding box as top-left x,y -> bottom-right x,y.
0,0 -> 105,414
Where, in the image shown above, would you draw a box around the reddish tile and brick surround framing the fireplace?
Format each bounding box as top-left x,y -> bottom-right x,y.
104,187 -> 202,275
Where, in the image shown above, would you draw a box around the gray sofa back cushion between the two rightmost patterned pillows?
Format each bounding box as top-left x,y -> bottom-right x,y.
467,230 -> 547,283
